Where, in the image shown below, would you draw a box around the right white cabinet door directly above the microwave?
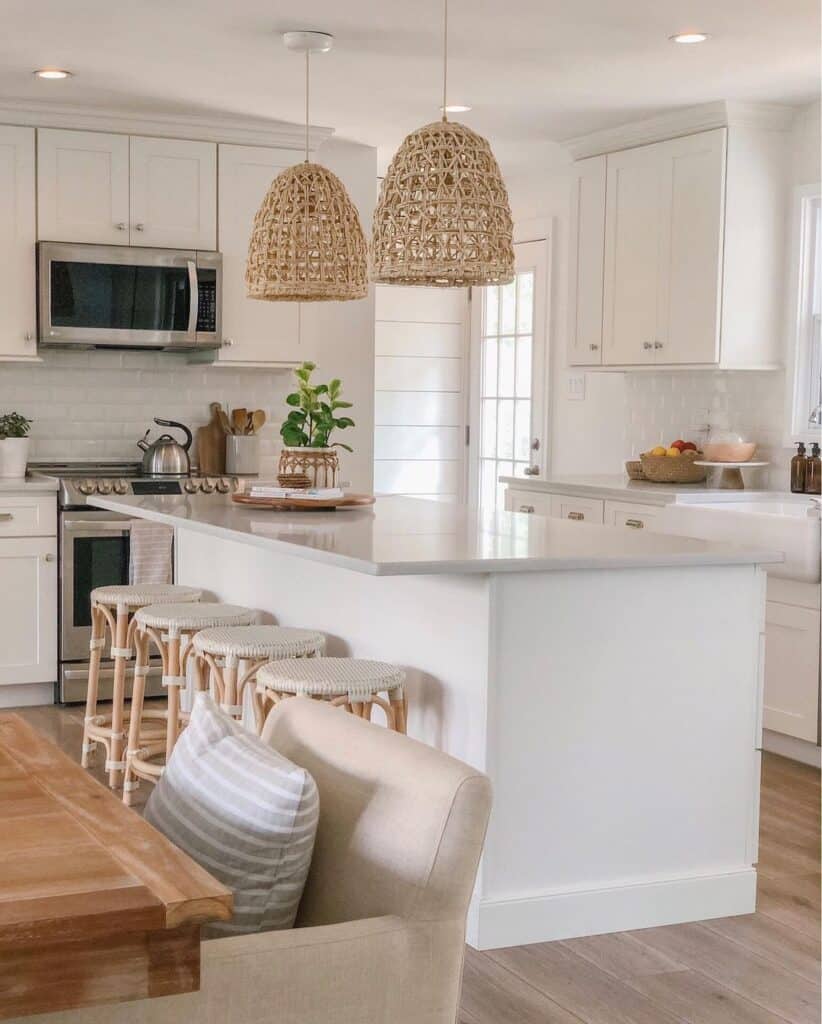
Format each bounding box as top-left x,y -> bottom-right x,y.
131,135 -> 217,249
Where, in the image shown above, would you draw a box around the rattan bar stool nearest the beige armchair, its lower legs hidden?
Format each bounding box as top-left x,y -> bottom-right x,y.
257,657 -> 408,732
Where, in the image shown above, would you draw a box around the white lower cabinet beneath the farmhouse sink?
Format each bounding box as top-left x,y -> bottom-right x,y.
763,593 -> 820,743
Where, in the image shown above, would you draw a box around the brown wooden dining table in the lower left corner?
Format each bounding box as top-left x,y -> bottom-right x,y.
0,714 -> 232,1020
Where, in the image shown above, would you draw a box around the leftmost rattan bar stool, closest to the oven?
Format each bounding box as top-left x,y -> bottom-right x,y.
81,584 -> 202,788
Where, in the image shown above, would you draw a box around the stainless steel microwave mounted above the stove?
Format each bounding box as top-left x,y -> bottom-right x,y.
37,242 -> 222,351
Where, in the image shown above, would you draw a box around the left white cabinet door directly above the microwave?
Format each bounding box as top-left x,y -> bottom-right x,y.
37,128 -> 129,245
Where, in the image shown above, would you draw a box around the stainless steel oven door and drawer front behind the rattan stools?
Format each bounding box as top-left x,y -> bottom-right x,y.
58,509 -> 162,703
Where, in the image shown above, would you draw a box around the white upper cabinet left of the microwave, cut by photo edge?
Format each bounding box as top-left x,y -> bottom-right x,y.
0,125 -> 37,359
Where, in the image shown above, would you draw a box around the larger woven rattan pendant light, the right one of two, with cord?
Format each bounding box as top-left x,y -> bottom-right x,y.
371,0 -> 514,288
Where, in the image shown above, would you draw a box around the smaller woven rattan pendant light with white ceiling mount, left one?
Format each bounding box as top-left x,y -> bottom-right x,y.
246,32 -> 369,302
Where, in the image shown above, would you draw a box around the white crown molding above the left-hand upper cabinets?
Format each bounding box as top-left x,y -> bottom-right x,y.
0,99 -> 334,152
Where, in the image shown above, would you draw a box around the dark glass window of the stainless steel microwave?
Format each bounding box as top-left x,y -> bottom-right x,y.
50,260 -> 191,332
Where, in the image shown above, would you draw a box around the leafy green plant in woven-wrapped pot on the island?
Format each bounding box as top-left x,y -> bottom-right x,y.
278,362 -> 354,487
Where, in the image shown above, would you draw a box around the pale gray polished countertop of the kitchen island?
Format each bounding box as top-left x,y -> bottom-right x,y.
94,495 -> 782,575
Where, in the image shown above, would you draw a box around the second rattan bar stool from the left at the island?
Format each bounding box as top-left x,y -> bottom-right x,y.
123,603 -> 257,804
